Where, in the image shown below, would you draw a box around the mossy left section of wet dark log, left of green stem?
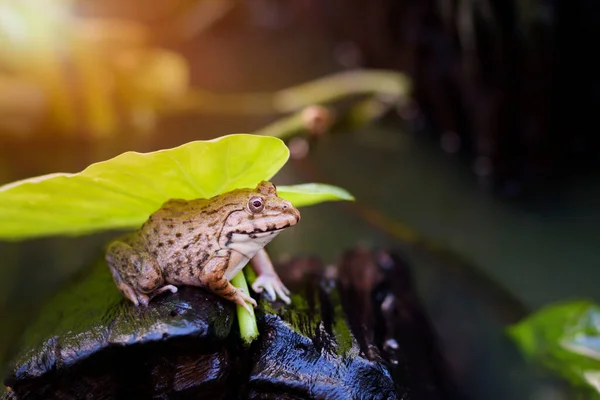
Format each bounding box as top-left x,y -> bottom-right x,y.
5,262 -> 236,399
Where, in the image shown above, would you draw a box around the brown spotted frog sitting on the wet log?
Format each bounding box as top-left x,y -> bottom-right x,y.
105,181 -> 300,311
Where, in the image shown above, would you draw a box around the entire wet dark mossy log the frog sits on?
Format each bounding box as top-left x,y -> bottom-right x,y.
5,249 -> 456,399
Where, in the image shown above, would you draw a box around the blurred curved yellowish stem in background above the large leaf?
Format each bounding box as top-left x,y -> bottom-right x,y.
164,69 -> 411,129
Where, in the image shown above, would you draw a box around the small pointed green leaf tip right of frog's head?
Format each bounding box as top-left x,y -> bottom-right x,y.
277,183 -> 354,207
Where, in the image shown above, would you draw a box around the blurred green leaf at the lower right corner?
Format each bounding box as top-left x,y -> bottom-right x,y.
508,300 -> 600,398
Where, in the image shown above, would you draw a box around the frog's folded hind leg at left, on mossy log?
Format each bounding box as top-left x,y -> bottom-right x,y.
106,241 -> 177,306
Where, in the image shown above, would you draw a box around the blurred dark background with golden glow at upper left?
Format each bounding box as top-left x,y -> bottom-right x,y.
0,0 -> 600,399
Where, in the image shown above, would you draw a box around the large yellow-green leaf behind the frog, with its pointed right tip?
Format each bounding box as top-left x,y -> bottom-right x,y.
0,134 -> 352,240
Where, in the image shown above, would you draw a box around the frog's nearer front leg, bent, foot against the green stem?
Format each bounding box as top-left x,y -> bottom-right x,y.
199,251 -> 256,312
